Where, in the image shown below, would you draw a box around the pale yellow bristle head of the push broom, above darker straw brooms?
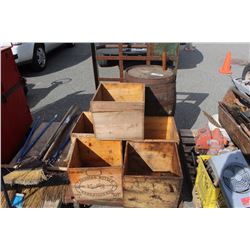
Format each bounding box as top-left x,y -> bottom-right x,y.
4,168 -> 47,186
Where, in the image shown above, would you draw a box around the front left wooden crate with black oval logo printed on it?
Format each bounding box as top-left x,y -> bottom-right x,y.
68,136 -> 123,204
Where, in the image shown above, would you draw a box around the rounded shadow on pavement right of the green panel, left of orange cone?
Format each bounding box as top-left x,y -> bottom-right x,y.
178,48 -> 204,69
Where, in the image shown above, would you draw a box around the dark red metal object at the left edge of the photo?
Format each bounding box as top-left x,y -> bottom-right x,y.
1,47 -> 32,163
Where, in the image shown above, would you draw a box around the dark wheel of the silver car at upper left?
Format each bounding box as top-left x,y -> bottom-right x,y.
31,43 -> 47,71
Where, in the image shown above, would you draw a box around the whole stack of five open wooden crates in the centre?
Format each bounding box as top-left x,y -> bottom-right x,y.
68,83 -> 182,207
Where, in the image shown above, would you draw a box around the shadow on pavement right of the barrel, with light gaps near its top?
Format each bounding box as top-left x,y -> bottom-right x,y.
175,92 -> 209,129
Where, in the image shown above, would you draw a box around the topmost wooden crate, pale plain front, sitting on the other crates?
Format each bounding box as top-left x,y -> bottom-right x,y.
90,83 -> 145,140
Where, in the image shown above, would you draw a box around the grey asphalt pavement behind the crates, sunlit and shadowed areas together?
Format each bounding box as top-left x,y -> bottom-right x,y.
20,43 -> 250,128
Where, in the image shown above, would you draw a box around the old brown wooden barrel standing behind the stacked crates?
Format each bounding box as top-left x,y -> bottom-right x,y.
125,65 -> 176,116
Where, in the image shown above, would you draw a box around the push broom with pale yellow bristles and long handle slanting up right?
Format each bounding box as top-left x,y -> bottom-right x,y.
4,106 -> 78,186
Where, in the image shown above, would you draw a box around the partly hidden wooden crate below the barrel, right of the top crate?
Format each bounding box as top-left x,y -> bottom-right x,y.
144,116 -> 180,144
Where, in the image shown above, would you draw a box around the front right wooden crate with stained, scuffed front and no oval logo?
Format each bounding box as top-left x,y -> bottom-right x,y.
123,141 -> 182,207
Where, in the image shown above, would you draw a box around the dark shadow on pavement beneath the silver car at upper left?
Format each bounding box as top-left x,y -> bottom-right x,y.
19,43 -> 91,77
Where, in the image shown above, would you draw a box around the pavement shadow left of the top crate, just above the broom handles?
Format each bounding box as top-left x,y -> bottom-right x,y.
32,91 -> 93,122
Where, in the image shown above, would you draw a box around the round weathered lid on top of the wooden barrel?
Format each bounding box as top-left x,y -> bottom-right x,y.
126,65 -> 174,80
